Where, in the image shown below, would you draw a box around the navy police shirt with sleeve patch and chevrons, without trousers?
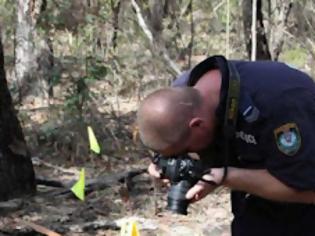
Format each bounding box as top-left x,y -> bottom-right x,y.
173,56 -> 315,190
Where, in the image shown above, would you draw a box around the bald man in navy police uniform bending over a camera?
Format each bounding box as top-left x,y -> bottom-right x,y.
138,56 -> 315,236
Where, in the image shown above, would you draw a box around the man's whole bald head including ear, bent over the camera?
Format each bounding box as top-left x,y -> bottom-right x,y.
138,87 -> 215,155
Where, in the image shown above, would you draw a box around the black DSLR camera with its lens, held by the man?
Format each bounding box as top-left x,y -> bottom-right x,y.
153,154 -> 205,215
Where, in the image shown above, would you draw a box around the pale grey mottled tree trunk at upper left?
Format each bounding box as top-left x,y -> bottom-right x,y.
15,0 -> 54,105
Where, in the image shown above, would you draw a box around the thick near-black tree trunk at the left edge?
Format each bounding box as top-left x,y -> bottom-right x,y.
0,31 -> 35,201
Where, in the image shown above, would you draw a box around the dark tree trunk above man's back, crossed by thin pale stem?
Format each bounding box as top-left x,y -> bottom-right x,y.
242,0 -> 271,60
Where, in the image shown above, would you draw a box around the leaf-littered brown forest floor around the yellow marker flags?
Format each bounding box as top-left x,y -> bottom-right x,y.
0,96 -> 231,236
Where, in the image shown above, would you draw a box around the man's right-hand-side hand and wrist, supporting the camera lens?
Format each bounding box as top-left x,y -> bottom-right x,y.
186,168 -> 224,202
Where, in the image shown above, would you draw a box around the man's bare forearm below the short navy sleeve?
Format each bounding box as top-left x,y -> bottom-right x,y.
223,167 -> 315,204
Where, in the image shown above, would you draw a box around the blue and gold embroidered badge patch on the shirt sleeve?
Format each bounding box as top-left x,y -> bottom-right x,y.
273,123 -> 301,156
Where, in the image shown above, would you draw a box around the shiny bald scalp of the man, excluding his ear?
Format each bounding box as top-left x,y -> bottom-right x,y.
137,87 -> 202,150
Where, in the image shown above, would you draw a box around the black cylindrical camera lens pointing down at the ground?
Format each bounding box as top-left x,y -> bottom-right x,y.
166,180 -> 192,215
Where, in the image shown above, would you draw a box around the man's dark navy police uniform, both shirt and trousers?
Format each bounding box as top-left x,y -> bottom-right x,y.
173,56 -> 315,236
